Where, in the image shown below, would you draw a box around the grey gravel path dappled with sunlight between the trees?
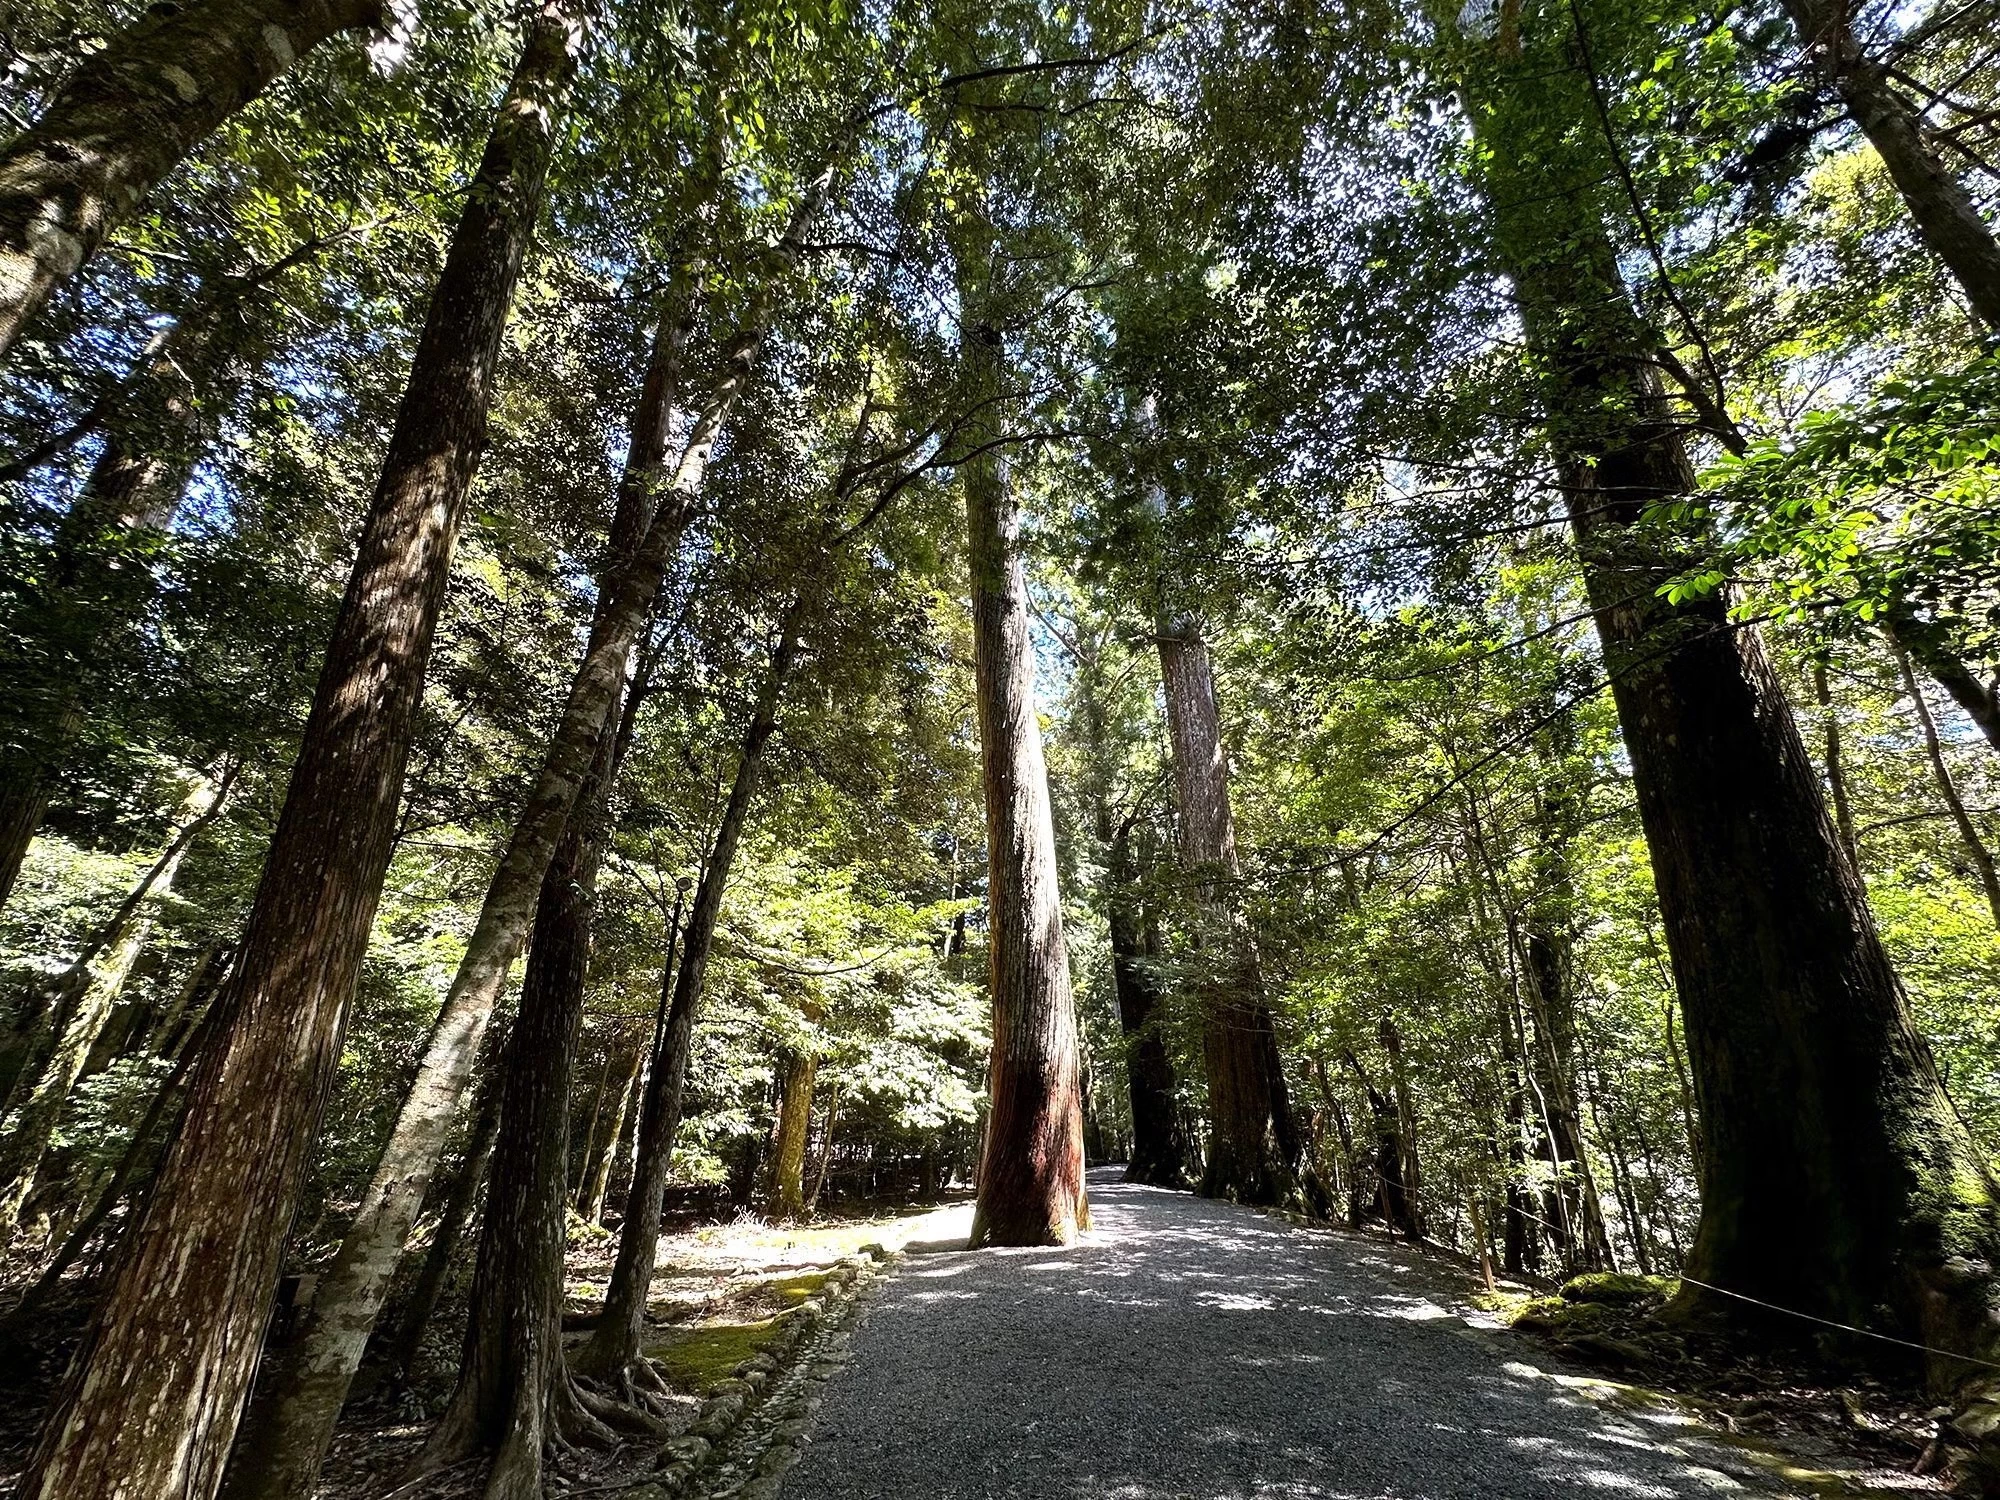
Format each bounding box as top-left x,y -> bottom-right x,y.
782,1168 -> 1896,1500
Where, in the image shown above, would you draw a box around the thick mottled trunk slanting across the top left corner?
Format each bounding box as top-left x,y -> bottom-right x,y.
0,0 -> 386,356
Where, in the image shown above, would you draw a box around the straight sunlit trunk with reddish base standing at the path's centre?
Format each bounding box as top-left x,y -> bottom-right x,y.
962,314 -> 1090,1248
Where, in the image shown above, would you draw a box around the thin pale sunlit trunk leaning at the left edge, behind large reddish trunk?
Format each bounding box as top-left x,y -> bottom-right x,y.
0,766 -> 236,1244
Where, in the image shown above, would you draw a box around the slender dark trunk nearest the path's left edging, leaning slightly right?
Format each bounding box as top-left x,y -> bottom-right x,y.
576,602 -> 802,1390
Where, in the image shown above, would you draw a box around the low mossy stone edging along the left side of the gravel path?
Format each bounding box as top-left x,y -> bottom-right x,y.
618,1244 -> 902,1500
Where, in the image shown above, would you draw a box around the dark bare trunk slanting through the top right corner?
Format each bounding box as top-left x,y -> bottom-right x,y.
1784,0 -> 2000,328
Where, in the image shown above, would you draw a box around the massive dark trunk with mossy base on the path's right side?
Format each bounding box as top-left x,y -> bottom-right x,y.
1466,5 -> 2000,1438
